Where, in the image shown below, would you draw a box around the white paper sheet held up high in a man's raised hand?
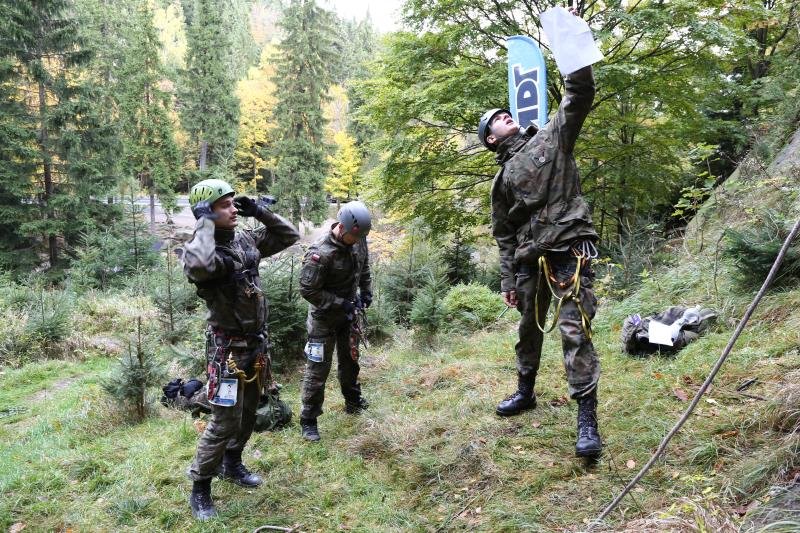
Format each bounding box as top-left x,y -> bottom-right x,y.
539,7 -> 603,75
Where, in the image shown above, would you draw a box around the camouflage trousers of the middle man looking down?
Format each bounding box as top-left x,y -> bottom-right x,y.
300,313 -> 361,418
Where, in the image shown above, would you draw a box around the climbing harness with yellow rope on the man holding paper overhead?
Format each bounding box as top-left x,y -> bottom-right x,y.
533,241 -> 598,340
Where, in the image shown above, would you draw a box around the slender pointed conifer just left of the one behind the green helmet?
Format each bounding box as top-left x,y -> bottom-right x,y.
116,0 -> 181,231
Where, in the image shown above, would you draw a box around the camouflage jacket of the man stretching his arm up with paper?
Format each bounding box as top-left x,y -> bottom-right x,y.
491,67 -> 597,291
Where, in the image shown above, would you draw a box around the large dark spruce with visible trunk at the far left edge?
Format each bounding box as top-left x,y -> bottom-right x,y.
3,0 -> 117,267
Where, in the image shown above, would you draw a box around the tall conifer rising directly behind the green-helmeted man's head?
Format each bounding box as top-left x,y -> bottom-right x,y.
180,0 -> 239,171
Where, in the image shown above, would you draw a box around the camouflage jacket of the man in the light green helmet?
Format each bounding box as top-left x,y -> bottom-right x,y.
183,209 -> 300,335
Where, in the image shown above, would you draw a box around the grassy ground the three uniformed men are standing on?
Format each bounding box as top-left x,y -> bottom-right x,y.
0,262 -> 800,531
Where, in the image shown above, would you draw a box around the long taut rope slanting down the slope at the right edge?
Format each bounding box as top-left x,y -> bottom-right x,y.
587,216 -> 800,531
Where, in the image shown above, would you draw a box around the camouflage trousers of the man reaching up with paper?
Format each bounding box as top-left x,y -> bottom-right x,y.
516,254 -> 600,399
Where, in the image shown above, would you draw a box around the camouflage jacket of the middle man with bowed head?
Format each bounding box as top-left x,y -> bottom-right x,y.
300,224 -> 372,316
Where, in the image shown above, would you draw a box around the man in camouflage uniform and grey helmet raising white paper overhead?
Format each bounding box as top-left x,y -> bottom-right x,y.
478,57 -> 602,457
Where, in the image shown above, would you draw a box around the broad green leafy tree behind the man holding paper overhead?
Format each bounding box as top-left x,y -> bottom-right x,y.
361,0 -> 741,238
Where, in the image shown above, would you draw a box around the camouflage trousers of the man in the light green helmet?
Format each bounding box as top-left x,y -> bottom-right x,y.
189,337 -> 263,481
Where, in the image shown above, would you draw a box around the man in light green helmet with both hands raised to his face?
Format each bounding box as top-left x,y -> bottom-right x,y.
183,179 -> 300,520
